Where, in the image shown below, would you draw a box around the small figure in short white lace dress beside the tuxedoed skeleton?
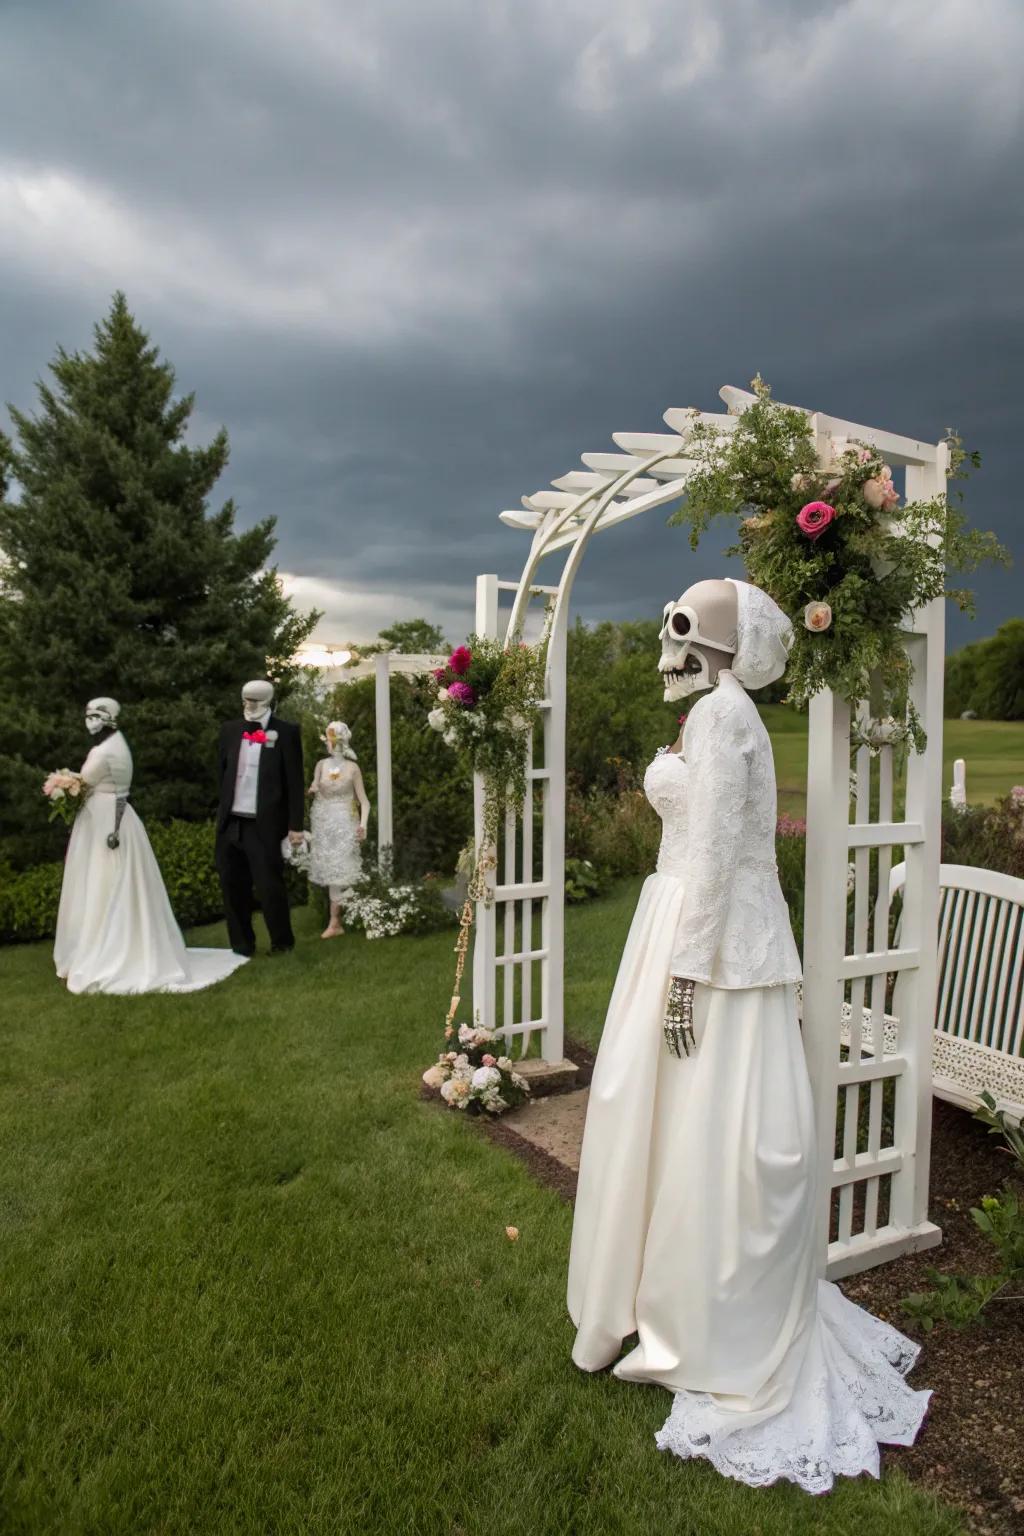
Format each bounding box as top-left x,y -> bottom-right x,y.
309,720 -> 370,938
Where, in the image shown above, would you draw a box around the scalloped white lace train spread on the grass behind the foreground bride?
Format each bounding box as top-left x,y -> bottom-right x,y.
657,1281 -> 930,1493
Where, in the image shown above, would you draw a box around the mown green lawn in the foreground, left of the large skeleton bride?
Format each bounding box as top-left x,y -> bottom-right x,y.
0,888 -> 961,1536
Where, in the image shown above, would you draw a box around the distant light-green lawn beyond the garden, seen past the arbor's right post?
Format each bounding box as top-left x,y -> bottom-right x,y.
761,703 -> 1024,816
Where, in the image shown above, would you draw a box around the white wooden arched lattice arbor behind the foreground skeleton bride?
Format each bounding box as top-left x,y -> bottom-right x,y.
473,387 -> 947,1278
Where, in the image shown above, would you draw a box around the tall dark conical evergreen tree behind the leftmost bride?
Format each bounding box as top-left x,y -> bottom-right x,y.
0,293 -> 318,863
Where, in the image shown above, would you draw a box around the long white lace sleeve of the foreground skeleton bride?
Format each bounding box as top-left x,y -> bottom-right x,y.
672,694 -> 754,985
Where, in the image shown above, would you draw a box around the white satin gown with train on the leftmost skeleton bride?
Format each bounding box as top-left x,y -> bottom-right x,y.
54,731 -> 246,992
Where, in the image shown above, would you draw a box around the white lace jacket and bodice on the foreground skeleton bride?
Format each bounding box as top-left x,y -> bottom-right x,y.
643,673 -> 800,988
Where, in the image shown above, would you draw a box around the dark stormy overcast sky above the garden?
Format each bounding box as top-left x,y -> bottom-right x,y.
0,0 -> 1024,644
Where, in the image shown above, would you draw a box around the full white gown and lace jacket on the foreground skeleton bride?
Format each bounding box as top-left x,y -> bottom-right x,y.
568,584 -> 929,1493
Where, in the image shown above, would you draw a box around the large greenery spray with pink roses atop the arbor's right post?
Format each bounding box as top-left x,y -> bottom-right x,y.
669,376 -> 1006,751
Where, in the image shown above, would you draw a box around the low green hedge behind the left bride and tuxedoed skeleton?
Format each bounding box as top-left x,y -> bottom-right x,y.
0,822 -> 307,943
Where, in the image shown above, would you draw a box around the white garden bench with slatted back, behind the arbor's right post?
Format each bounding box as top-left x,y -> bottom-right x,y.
843,863 -> 1024,1120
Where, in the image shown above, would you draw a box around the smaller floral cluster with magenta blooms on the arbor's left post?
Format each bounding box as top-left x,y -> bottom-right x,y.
427,634 -> 545,845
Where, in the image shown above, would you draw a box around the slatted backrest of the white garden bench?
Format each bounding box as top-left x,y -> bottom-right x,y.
889,865 -> 1024,1057
